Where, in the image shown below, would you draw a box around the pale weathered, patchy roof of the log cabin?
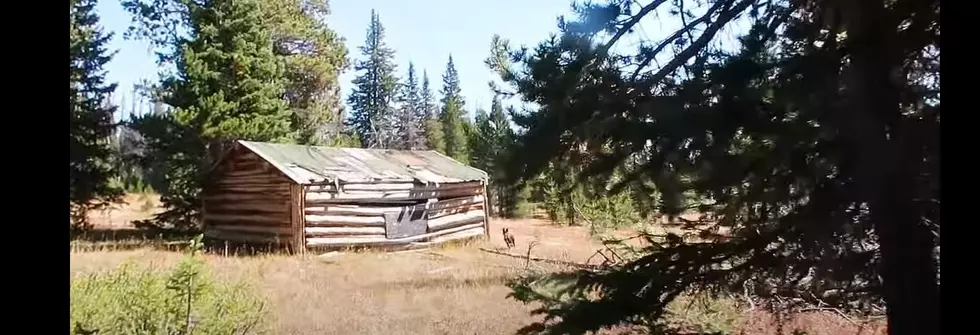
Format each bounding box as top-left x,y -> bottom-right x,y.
238,141 -> 488,184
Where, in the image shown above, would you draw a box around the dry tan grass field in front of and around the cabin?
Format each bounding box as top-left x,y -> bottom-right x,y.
70,196 -> 884,335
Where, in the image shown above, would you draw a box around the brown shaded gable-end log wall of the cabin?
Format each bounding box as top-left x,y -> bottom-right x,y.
202,148 -> 294,245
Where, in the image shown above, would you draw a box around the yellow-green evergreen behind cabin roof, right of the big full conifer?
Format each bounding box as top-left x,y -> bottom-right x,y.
259,0 -> 349,144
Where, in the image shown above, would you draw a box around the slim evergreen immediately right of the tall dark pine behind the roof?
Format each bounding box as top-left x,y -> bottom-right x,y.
395,62 -> 425,150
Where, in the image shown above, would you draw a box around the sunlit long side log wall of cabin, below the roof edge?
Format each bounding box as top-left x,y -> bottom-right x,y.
304,181 -> 487,248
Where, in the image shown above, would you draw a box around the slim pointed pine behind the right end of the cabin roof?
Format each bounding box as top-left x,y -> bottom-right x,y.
439,55 -> 469,163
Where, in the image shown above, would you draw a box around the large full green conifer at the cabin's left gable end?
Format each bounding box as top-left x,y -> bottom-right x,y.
124,0 -> 293,227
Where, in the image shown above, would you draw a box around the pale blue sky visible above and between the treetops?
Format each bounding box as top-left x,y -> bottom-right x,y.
98,0 -> 571,120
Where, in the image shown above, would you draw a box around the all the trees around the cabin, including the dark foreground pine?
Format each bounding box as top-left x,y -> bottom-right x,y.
70,0 -> 941,334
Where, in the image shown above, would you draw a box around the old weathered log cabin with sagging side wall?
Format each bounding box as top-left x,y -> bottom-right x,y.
202,141 -> 489,252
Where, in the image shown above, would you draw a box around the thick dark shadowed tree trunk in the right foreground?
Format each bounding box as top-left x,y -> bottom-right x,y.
841,0 -> 941,335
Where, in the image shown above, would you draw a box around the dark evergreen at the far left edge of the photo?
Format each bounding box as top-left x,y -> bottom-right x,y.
68,0 -> 121,226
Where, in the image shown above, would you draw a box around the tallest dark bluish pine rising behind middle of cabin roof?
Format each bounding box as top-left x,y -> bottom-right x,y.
348,10 -> 398,148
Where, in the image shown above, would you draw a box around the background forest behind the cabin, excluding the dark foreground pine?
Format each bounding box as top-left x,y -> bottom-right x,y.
71,0 -> 649,232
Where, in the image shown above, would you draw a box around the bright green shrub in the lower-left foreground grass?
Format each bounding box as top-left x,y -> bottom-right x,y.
69,238 -> 267,335
